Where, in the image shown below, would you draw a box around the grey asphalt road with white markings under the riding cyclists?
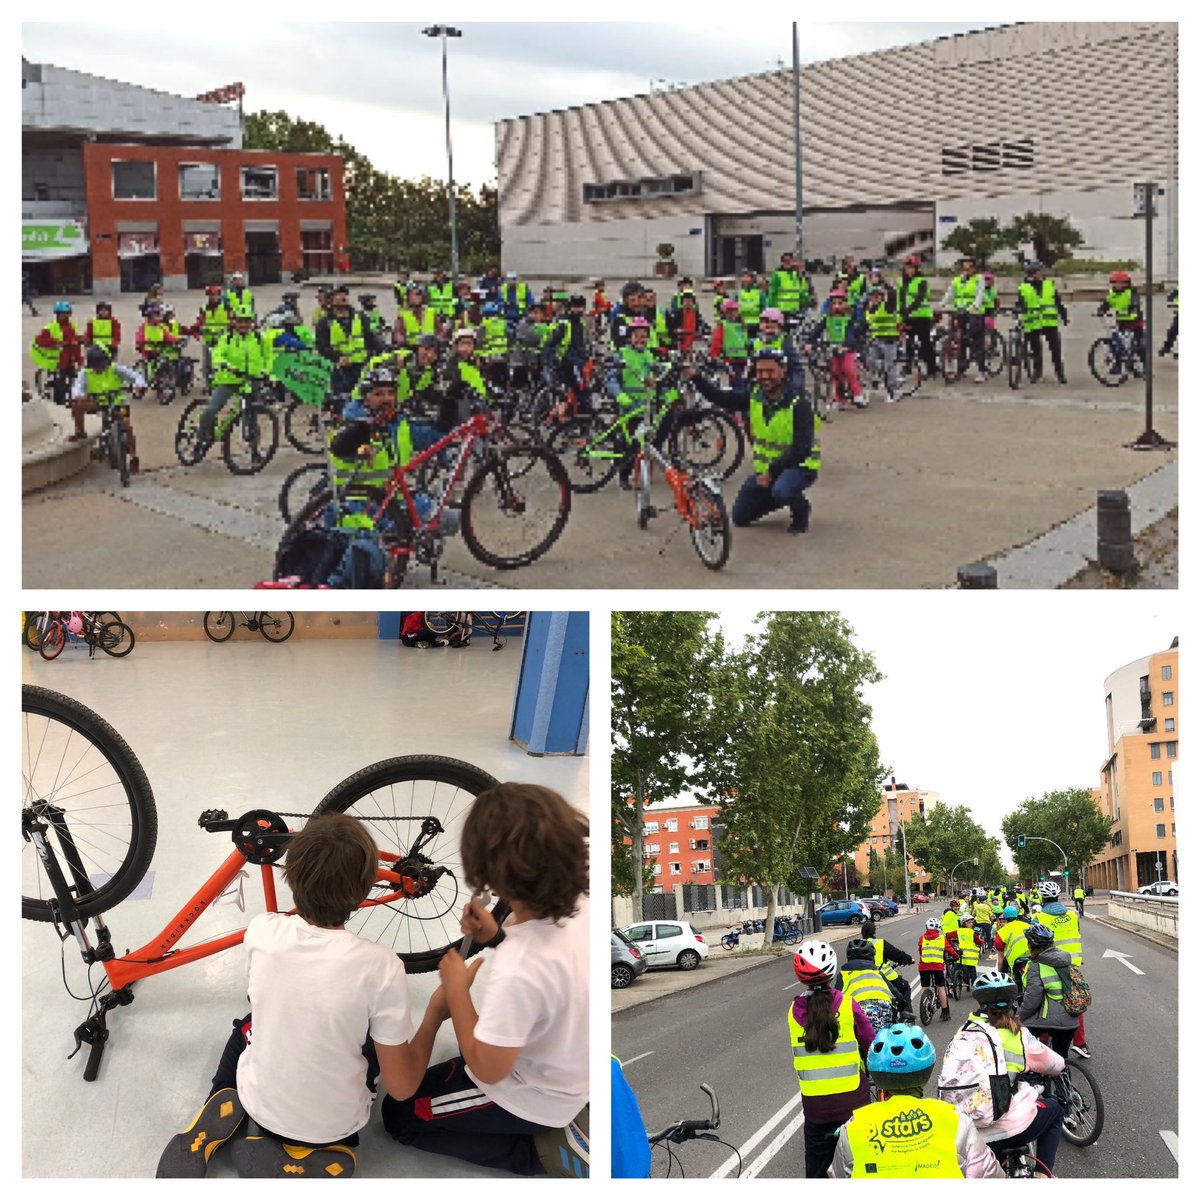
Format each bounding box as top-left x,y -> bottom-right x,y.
612,906 -> 1178,1178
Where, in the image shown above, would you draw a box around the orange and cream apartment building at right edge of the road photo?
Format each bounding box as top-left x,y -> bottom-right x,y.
1085,638 -> 1180,892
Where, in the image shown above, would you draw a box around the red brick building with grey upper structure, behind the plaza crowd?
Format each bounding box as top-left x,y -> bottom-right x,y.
22,61 -> 347,294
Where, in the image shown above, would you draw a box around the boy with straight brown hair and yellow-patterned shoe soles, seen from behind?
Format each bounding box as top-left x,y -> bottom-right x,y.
157,812 -> 440,1178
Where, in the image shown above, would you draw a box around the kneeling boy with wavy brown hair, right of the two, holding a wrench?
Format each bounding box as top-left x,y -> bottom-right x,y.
383,784 -> 588,1175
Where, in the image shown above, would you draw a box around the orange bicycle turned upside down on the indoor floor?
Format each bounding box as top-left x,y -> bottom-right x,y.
20,684 -> 509,1082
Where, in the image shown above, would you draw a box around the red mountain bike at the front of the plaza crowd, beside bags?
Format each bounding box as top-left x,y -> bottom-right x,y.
274,409 -> 571,588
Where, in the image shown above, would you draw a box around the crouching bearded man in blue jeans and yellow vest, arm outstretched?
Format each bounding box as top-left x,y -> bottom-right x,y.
684,347 -> 821,533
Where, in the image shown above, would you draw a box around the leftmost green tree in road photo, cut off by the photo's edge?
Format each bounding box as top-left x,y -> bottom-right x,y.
611,612 -> 722,920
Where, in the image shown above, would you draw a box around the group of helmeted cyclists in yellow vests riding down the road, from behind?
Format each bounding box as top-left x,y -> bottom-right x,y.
788,881 -> 1087,1178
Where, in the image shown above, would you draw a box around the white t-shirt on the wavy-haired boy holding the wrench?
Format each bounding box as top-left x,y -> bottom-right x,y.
467,896 -> 588,1128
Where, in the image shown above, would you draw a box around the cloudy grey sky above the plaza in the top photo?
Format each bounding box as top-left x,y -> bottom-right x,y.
22,17 -> 993,185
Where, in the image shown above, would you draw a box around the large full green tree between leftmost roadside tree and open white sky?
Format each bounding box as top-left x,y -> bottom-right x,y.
701,612 -> 884,944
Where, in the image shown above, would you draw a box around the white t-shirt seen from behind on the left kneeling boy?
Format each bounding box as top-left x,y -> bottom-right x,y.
238,912 -> 413,1142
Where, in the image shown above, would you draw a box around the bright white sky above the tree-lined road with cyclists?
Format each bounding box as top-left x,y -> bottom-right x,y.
667,590 -> 1182,866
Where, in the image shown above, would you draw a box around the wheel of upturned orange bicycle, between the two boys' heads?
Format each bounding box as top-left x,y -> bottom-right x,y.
313,755 -> 509,973
